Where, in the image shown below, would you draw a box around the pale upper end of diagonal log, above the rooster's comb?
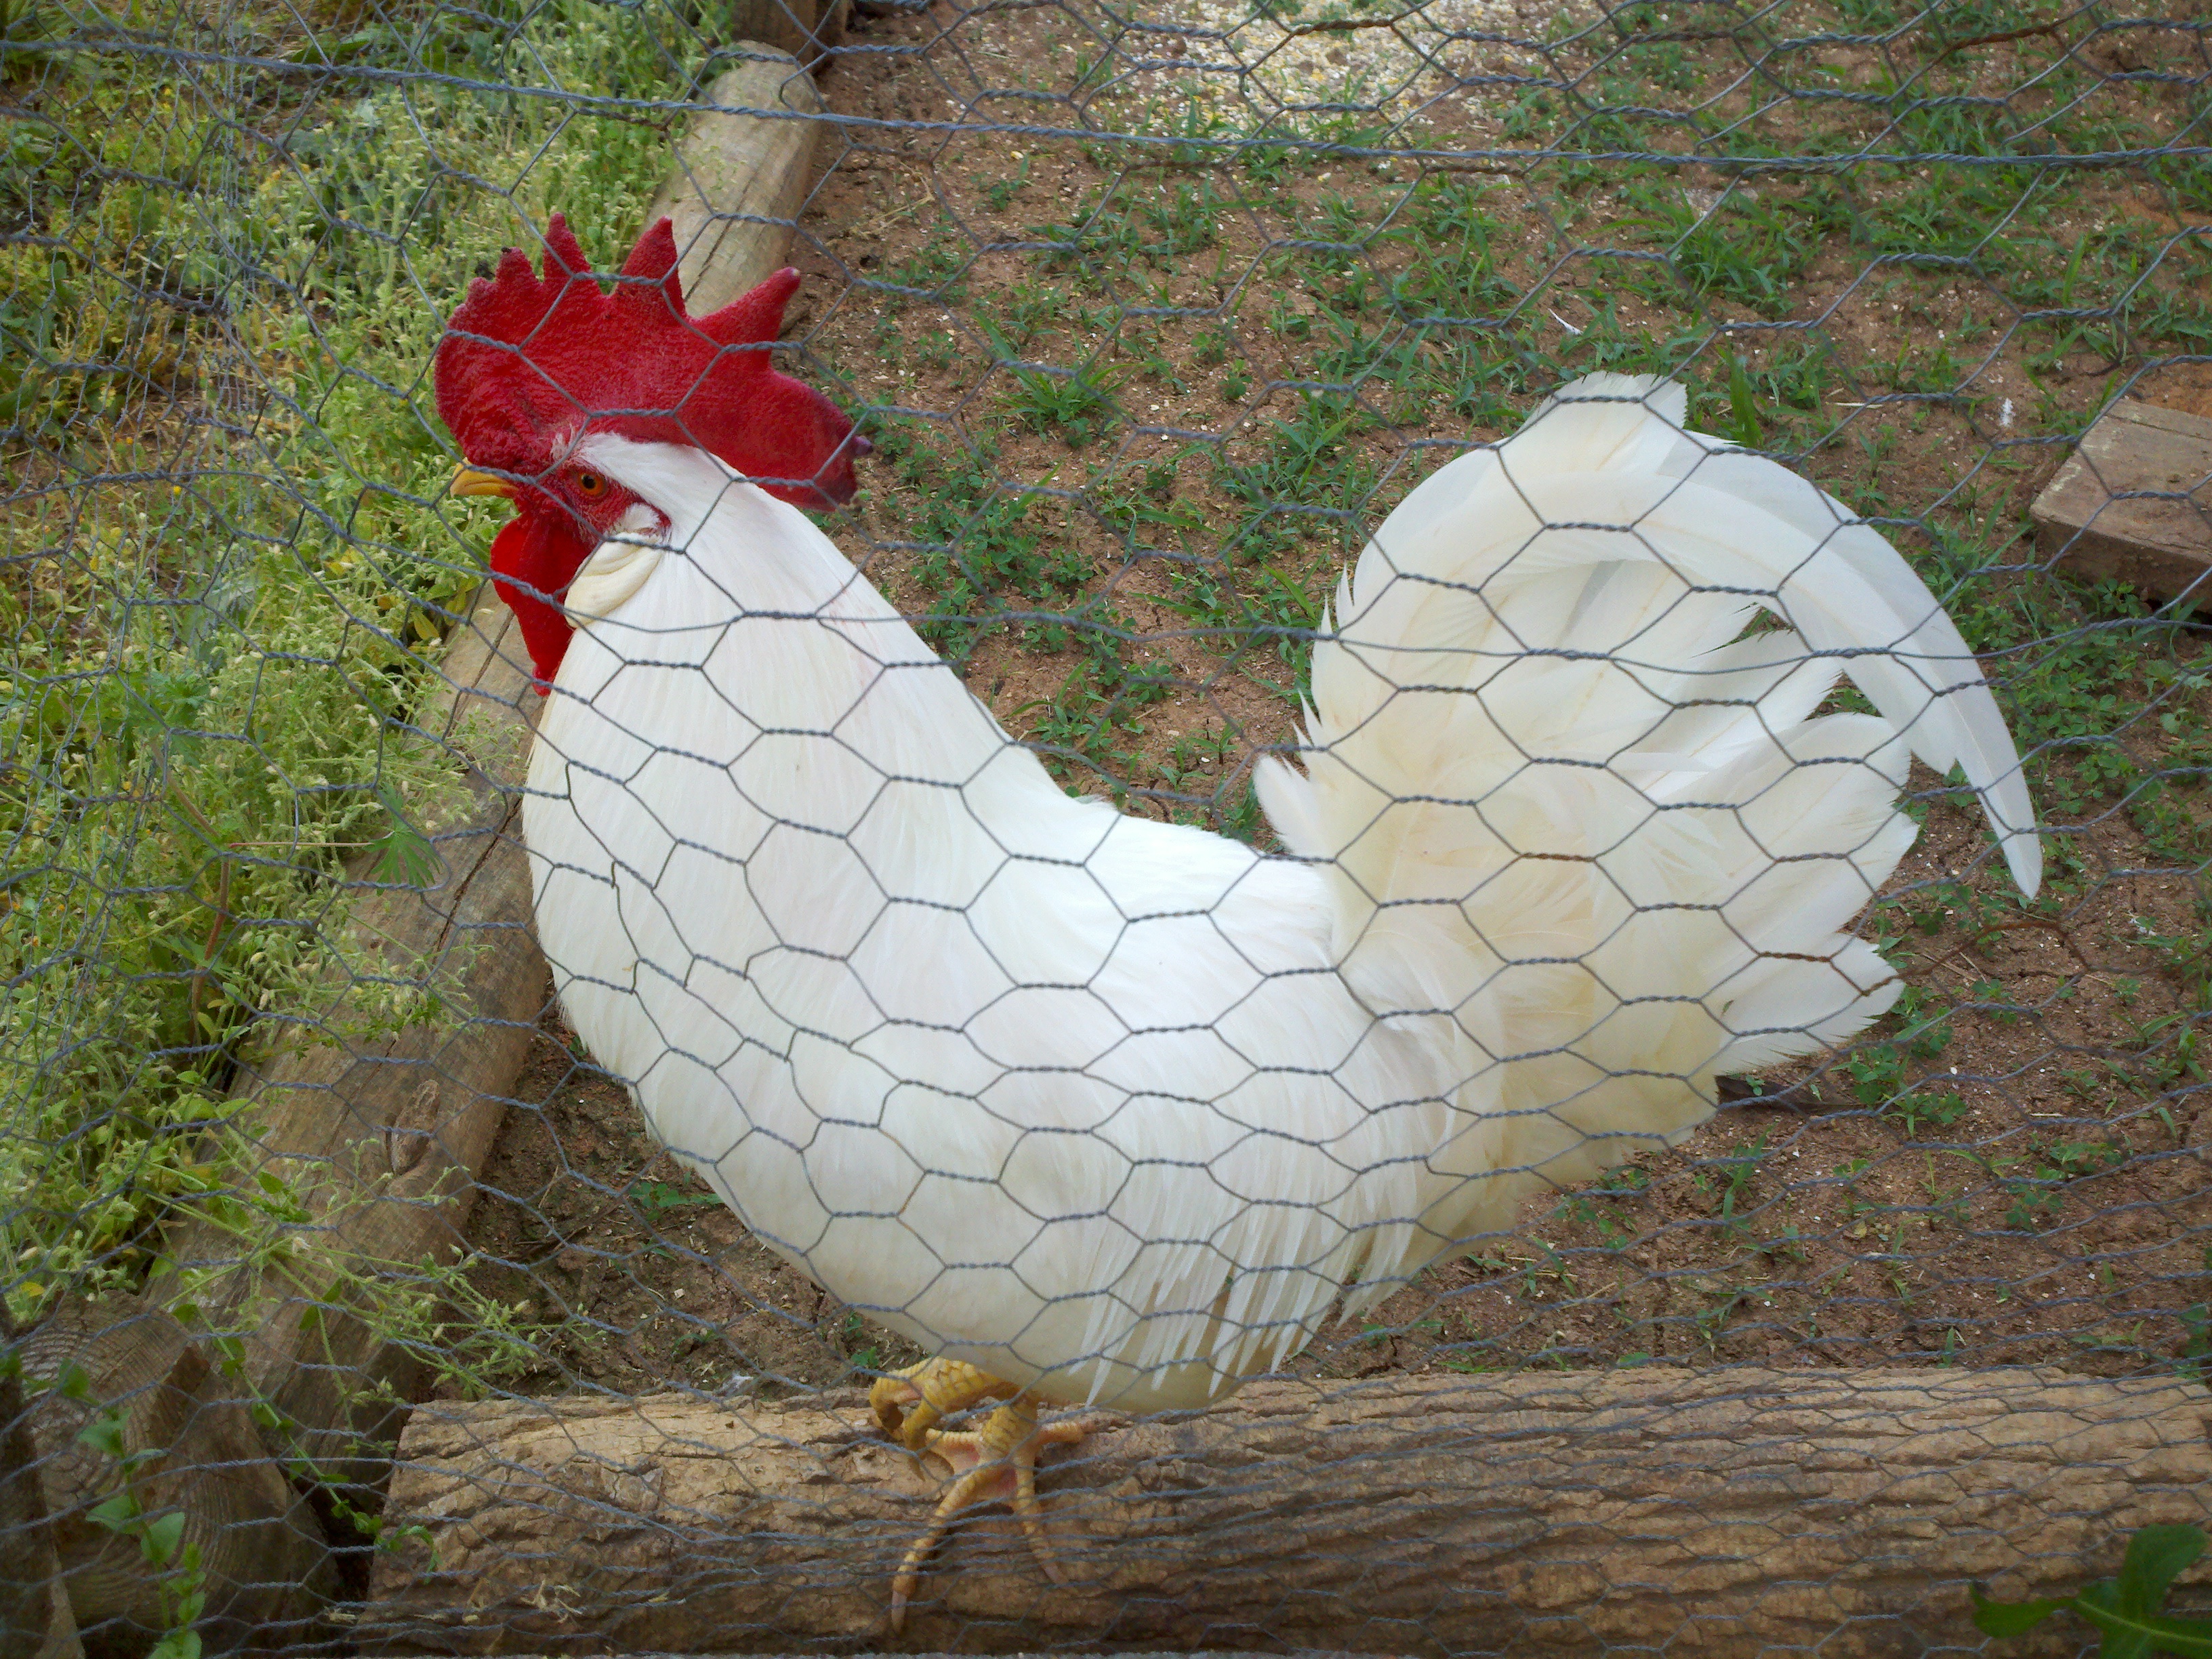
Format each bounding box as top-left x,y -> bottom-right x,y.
646,49 -> 823,316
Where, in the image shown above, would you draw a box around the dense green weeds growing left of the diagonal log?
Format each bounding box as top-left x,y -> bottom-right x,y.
0,0 -> 670,1314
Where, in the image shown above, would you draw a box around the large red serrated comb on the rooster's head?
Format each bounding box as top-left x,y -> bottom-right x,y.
436,212 -> 856,506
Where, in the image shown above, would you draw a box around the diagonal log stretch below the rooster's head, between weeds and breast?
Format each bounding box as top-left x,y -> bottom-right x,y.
148,584 -> 551,1480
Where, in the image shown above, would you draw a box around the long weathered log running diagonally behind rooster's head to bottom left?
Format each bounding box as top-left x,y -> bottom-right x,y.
0,39 -> 836,1659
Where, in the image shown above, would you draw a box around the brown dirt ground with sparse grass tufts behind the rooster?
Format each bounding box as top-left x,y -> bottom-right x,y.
449,0 -> 2212,1415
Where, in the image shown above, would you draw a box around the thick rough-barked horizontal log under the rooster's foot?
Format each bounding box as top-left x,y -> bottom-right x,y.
361,1369 -> 2212,1659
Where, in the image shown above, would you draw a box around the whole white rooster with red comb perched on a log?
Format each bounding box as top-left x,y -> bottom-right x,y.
438,217 -> 2042,1628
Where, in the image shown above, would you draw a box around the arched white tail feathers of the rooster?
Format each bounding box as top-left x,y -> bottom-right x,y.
1258,374 -> 2042,1221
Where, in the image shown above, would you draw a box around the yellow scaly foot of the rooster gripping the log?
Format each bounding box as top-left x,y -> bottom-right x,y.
867,1360 -> 1084,1635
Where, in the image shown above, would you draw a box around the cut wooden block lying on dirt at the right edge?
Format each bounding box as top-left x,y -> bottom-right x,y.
2028,398 -> 2212,606
